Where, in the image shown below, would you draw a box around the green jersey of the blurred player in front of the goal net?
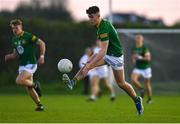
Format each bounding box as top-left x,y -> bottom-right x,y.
133,45 -> 150,69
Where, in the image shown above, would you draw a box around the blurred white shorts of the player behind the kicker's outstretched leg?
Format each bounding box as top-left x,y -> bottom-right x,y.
88,65 -> 108,79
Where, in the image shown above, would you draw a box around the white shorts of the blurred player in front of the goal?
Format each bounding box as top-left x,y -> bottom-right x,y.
132,68 -> 152,79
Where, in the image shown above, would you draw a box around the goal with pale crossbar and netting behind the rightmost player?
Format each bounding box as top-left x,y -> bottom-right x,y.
110,29 -> 180,93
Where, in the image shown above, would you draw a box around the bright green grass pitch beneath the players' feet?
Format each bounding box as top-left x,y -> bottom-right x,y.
0,93 -> 180,123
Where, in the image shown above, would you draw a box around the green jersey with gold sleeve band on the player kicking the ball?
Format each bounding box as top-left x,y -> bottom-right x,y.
97,20 -> 123,57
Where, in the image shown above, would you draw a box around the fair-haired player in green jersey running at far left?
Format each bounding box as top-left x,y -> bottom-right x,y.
5,19 -> 45,111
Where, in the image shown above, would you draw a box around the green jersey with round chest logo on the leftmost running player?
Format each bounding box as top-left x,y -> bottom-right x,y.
12,32 -> 38,65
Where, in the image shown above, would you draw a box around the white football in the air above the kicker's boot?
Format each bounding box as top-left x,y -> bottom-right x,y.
58,59 -> 73,73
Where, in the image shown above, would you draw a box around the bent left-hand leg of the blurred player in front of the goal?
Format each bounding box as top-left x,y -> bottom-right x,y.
131,69 -> 145,98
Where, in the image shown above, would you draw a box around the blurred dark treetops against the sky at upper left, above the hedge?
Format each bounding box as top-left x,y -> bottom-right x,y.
0,0 -> 73,21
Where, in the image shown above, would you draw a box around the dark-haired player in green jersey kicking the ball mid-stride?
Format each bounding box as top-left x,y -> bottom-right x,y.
63,6 -> 144,116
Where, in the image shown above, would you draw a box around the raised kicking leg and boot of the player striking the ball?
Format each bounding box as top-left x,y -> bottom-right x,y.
62,59 -> 105,90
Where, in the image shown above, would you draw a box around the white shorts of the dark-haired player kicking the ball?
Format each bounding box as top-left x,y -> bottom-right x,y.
104,55 -> 124,70
